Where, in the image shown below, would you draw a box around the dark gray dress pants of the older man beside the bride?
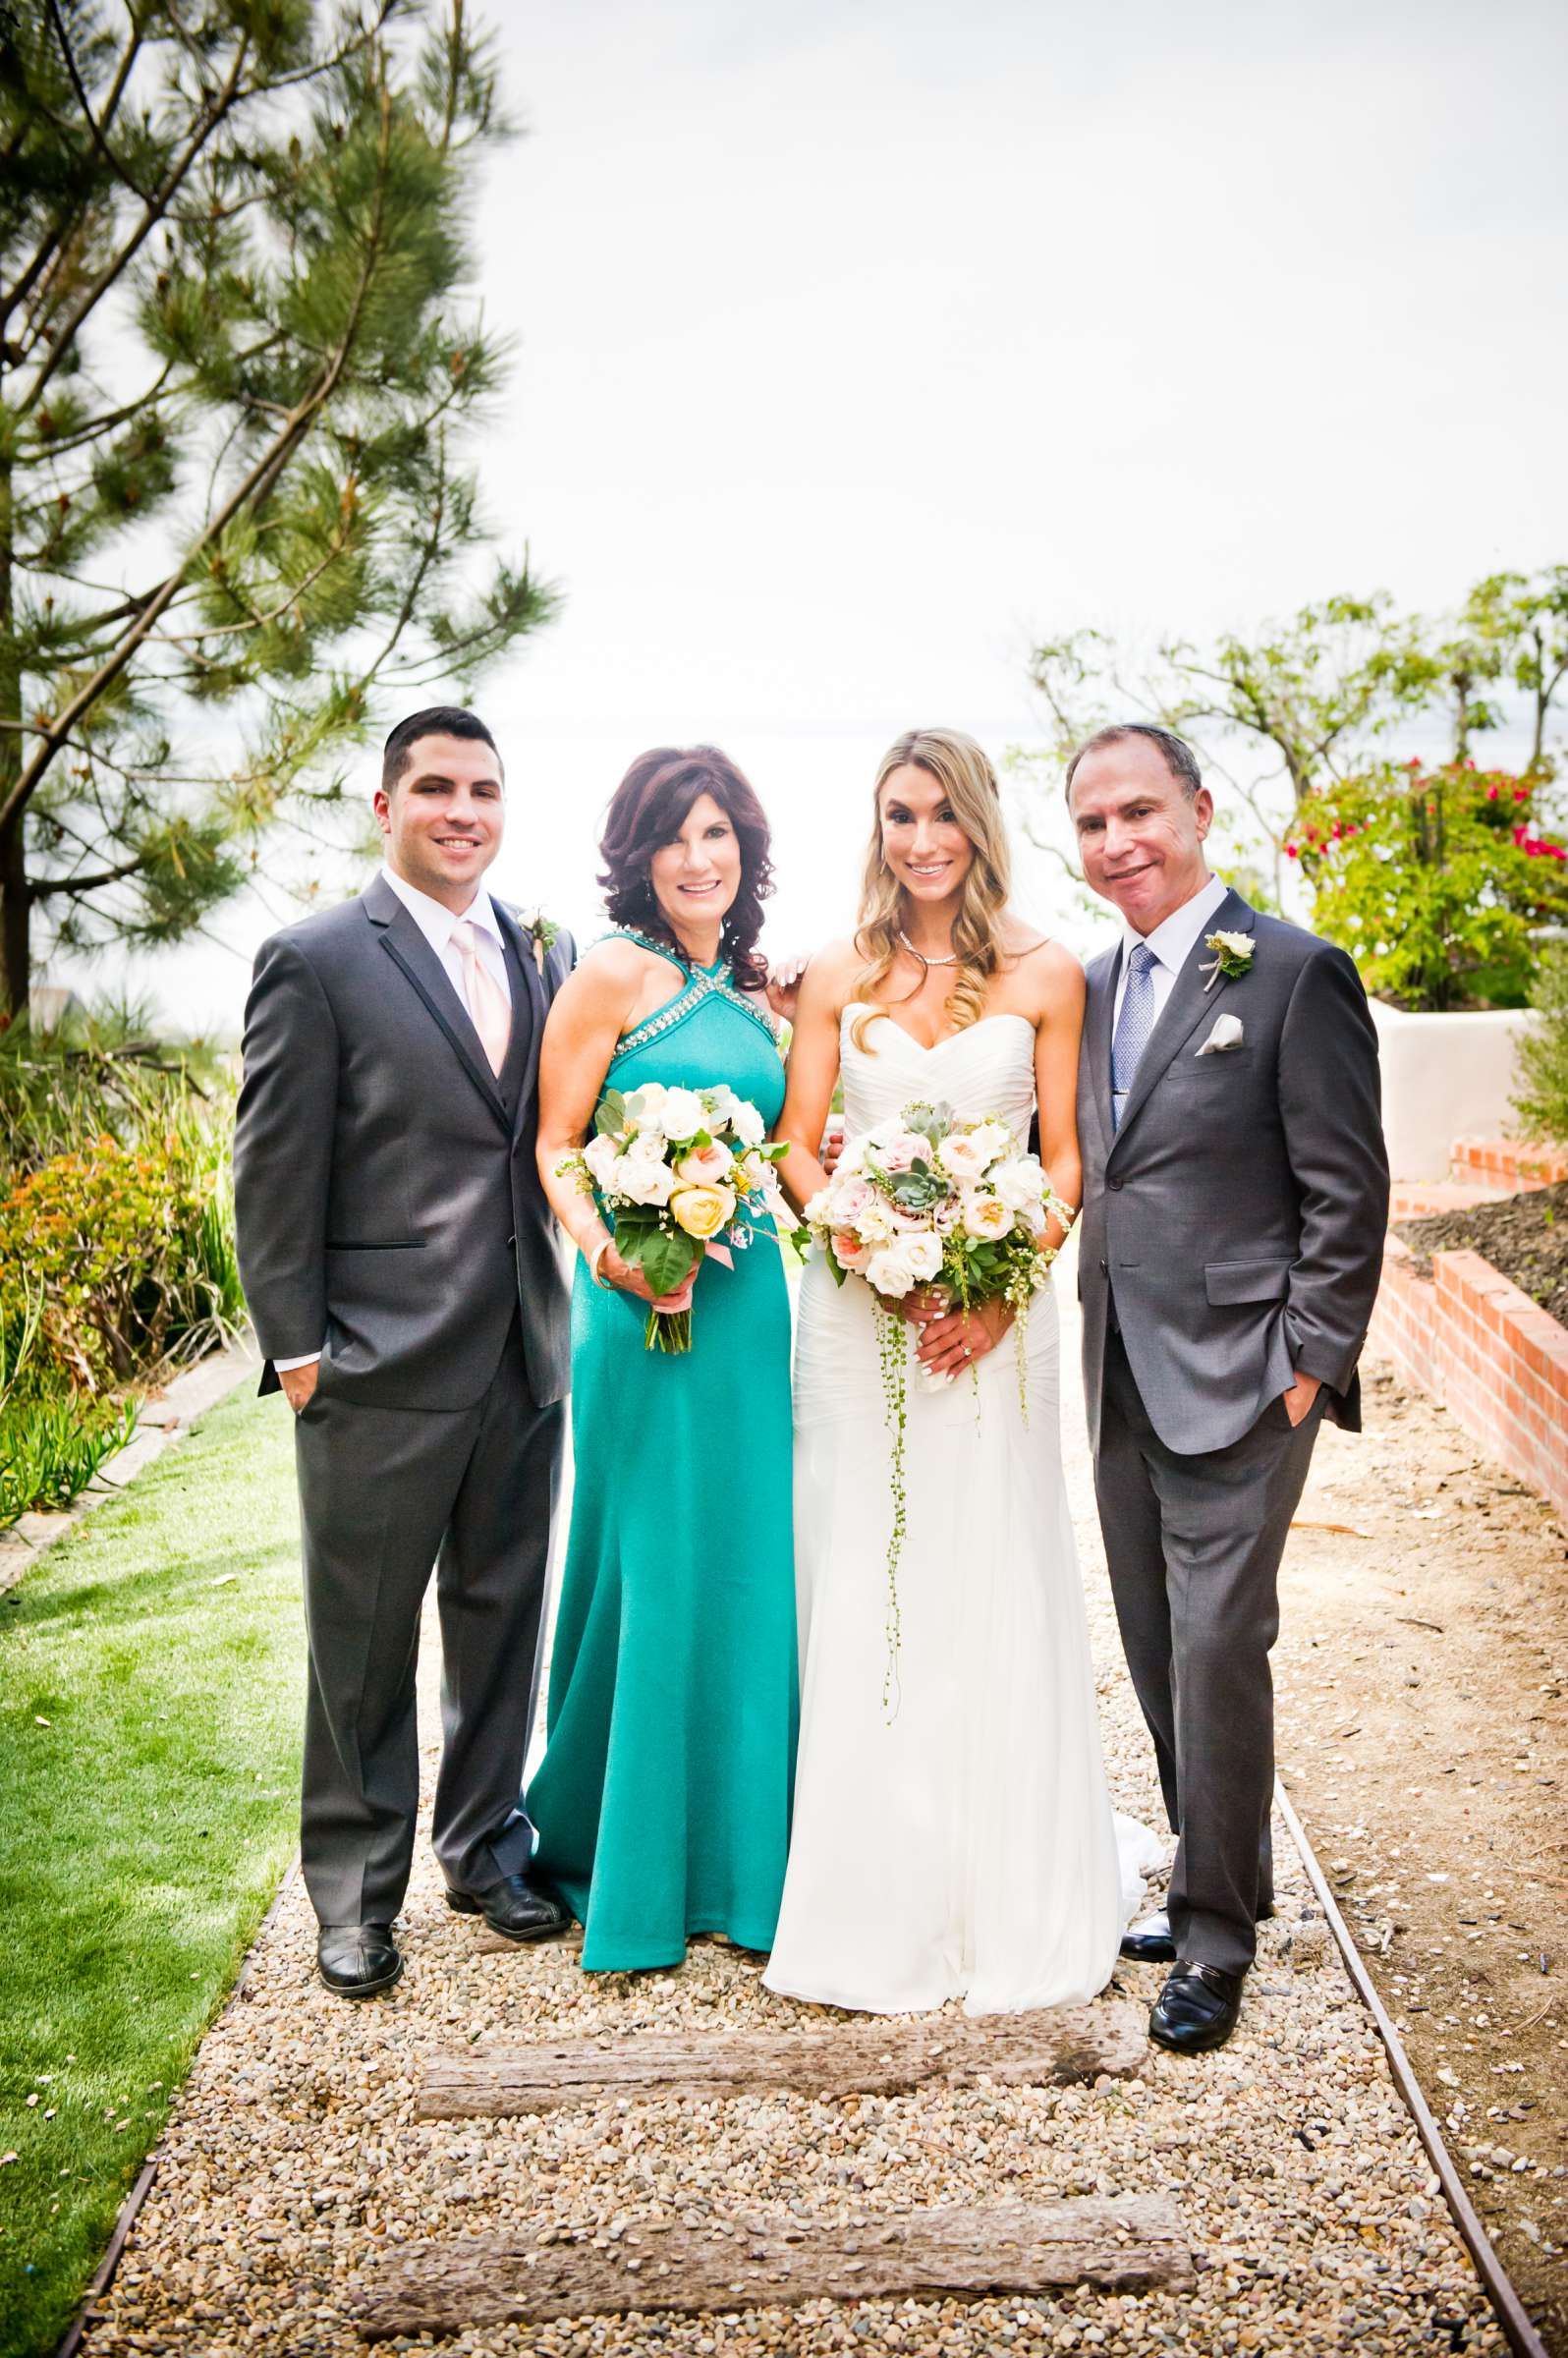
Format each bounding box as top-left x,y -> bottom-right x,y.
1094,1330 -> 1322,1974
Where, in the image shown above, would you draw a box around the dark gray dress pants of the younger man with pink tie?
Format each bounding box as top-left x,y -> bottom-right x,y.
295,1320 -> 564,1924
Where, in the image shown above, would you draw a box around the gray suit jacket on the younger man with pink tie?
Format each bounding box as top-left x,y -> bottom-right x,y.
234,874 -> 576,1410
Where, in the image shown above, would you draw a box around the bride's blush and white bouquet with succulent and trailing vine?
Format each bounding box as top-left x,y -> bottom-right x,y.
804,1106 -> 1078,1708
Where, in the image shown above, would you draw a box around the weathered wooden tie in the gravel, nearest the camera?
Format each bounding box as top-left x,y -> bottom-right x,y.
349,2195 -> 1193,2341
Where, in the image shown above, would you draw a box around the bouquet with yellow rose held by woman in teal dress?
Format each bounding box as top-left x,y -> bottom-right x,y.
559,1080 -> 792,1351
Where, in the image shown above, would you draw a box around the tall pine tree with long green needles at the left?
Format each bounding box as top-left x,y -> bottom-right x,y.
0,0 -> 554,1012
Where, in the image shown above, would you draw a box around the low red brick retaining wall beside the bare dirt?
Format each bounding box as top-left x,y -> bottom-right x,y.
1372,1235 -> 1568,1516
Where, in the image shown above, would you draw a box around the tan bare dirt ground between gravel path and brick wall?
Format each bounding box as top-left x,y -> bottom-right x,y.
1273,1368 -> 1568,2353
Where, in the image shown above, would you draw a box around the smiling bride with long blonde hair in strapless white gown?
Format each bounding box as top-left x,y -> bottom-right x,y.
764,731 -> 1160,2014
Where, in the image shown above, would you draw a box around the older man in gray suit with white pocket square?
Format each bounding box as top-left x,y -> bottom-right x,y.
1068,724 -> 1389,2053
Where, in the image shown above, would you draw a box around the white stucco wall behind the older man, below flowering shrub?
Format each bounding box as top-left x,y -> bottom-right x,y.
1372,1000 -> 1540,1179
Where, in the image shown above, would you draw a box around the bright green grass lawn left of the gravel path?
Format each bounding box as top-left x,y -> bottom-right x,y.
0,1396 -> 305,2358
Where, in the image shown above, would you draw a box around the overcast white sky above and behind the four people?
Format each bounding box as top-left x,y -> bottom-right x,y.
58,0 -> 1568,1021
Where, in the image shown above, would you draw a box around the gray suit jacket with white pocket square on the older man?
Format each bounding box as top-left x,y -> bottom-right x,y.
1078,891 -> 1389,1457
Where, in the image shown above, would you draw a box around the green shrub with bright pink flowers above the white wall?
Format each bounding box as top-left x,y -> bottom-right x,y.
1285,761 -> 1568,1009
